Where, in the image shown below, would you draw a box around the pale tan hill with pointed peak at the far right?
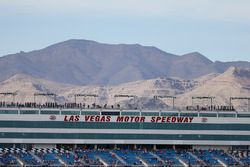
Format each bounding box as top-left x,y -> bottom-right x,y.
177,67 -> 250,109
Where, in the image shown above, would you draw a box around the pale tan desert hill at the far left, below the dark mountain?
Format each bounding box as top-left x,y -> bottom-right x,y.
0,74 -> 74,103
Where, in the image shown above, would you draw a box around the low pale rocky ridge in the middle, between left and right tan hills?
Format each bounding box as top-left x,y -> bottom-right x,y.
62,78 -> 199,104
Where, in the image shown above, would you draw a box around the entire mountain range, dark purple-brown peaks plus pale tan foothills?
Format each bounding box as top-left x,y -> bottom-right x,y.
0,40 -> 250,110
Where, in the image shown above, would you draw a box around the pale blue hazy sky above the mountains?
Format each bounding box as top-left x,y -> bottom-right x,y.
0,0 -> 250,61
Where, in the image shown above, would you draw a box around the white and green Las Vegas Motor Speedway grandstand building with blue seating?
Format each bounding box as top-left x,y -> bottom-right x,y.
0,93 -> 250,167
